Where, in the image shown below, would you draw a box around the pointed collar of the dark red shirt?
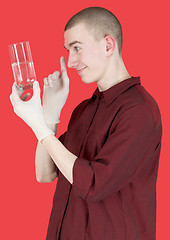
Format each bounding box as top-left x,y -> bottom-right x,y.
91,77 -> 141,107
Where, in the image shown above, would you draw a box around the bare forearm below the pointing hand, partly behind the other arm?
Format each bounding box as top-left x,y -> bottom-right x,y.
35,124 -> 57,182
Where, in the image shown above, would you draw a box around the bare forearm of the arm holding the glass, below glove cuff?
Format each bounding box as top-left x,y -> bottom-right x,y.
41,135 -> 77,184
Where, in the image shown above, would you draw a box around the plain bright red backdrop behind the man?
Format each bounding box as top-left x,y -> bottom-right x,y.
0,0 -> 170,240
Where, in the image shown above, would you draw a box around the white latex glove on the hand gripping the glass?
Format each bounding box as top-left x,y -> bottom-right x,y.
10,81 -> 54,141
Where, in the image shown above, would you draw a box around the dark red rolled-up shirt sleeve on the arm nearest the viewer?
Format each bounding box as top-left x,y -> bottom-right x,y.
72,104 -> 157,201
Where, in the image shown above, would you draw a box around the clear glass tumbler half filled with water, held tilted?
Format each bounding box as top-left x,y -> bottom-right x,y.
9,41 -> 36,90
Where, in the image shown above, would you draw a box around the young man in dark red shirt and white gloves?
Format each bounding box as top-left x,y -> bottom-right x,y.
11,7 -> 162,240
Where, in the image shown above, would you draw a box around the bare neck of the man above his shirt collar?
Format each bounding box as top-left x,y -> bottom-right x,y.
97,58 -> 131,92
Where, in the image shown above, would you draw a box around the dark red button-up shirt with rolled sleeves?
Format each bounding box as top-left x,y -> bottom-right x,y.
46,77 -> 162,240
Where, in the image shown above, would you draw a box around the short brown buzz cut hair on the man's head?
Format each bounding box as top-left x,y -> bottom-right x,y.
64,7 -> 123,55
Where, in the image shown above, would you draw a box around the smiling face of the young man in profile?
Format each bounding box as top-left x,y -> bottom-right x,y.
64,24 -> 107,83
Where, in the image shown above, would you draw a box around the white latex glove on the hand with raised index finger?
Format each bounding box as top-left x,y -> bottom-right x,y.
43,57 -> 69,123
